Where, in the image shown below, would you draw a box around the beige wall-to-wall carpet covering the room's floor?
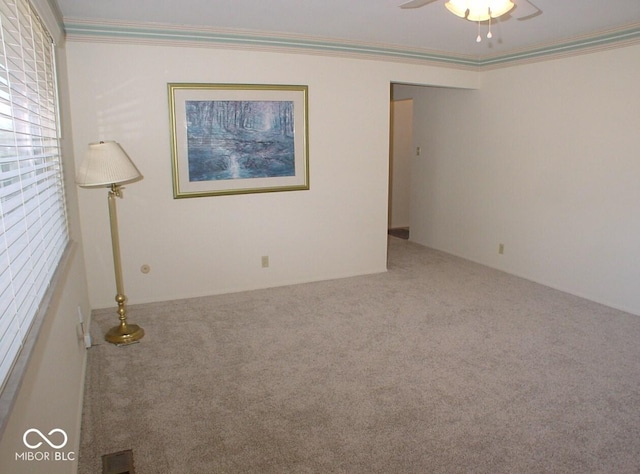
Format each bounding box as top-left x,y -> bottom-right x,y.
79,238 -> 640,474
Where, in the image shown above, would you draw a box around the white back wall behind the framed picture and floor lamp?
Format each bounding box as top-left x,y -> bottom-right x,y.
68,41 -> 477,308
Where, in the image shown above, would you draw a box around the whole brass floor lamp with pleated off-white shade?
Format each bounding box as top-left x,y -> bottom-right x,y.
76,141 -> 144,345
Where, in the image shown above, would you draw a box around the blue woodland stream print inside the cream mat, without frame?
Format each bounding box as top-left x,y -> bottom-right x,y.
186,100 -> 295,181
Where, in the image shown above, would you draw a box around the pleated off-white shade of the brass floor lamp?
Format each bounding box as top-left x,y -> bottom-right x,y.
76,141 -> 142,188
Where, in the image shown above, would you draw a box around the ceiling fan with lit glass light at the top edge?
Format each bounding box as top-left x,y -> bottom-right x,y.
400,0 -> 542,21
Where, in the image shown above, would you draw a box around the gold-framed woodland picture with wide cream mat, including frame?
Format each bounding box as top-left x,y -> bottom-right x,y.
168,83 -> 309,198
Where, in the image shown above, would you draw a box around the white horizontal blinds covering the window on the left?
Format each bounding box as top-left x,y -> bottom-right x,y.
0,0 -> 68,392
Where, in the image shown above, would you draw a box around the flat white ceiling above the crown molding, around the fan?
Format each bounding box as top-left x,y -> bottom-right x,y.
57,0 -> 640,59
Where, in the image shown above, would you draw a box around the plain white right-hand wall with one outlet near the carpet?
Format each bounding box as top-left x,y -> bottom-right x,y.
398,46 -> 640,314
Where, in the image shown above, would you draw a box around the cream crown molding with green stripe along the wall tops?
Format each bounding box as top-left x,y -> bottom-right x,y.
64,18 -> 640,70
